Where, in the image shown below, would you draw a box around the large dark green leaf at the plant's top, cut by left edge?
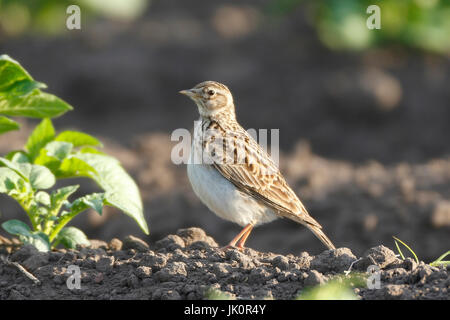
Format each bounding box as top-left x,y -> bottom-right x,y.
0,55 -> 72,118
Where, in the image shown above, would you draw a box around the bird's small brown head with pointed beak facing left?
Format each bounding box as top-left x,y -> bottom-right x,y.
180,81 -> 234,118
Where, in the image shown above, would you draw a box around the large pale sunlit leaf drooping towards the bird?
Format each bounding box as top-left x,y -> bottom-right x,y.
74,153 -> 149,234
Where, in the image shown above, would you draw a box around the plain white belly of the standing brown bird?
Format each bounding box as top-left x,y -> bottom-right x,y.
187,143 -> 278,226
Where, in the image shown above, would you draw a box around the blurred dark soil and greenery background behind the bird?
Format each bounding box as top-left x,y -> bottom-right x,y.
0,0 -> 450,261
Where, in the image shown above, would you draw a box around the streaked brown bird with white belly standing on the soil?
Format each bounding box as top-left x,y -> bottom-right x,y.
179,81 -> 335,250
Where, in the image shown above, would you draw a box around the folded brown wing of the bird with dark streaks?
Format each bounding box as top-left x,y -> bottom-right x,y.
203,122 -> 320,227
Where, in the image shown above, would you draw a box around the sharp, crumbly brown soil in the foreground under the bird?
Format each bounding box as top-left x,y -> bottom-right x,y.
0,228 -> 450,300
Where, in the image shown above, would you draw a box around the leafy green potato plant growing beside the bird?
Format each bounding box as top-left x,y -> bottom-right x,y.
0,55 -> 148,251
